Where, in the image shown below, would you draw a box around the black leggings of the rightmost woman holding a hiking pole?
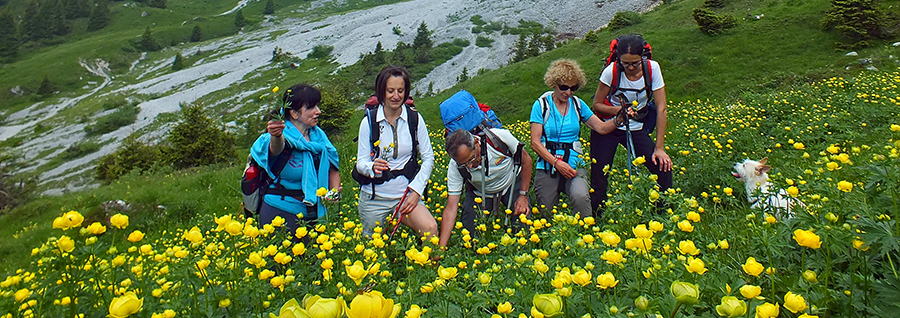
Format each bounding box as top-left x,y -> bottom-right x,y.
591,129 -> 672,209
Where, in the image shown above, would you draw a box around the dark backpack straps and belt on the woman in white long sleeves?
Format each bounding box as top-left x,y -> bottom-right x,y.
350,95 -> 428,199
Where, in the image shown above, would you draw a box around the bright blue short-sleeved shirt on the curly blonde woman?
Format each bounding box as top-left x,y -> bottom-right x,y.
530,92 -> 594,170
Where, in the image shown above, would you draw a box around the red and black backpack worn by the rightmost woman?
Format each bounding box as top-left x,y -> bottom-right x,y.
601,37 -> 656,132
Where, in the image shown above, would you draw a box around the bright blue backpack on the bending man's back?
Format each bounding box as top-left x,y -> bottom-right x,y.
440,90 -> 502,135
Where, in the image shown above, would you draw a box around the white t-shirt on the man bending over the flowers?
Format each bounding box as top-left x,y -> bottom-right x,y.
447,128 -> 519,195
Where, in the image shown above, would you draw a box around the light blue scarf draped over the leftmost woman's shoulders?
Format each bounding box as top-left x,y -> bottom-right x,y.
250,121 -> 339,217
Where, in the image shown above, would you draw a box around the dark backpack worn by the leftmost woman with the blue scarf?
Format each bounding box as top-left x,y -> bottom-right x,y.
241,143 -> 303,218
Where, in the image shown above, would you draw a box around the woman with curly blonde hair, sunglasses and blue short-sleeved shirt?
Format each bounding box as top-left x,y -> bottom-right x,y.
530,59 -> 621,218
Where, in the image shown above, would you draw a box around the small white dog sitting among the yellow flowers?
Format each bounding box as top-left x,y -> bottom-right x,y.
731,158 -> 802,218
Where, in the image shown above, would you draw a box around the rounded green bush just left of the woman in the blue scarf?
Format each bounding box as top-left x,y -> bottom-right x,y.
161,103 -> 237,169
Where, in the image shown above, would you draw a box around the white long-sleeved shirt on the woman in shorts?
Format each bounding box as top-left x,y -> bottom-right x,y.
356,106 -> 434,199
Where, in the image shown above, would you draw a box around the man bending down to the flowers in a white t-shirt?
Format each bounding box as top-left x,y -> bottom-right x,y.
440,128 -> 532,246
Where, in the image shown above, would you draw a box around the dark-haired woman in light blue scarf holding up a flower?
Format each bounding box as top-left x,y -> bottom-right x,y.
250,84 -> 341,237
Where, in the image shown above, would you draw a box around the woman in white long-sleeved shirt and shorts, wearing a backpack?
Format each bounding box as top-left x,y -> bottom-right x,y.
354,65 -> 437,237
